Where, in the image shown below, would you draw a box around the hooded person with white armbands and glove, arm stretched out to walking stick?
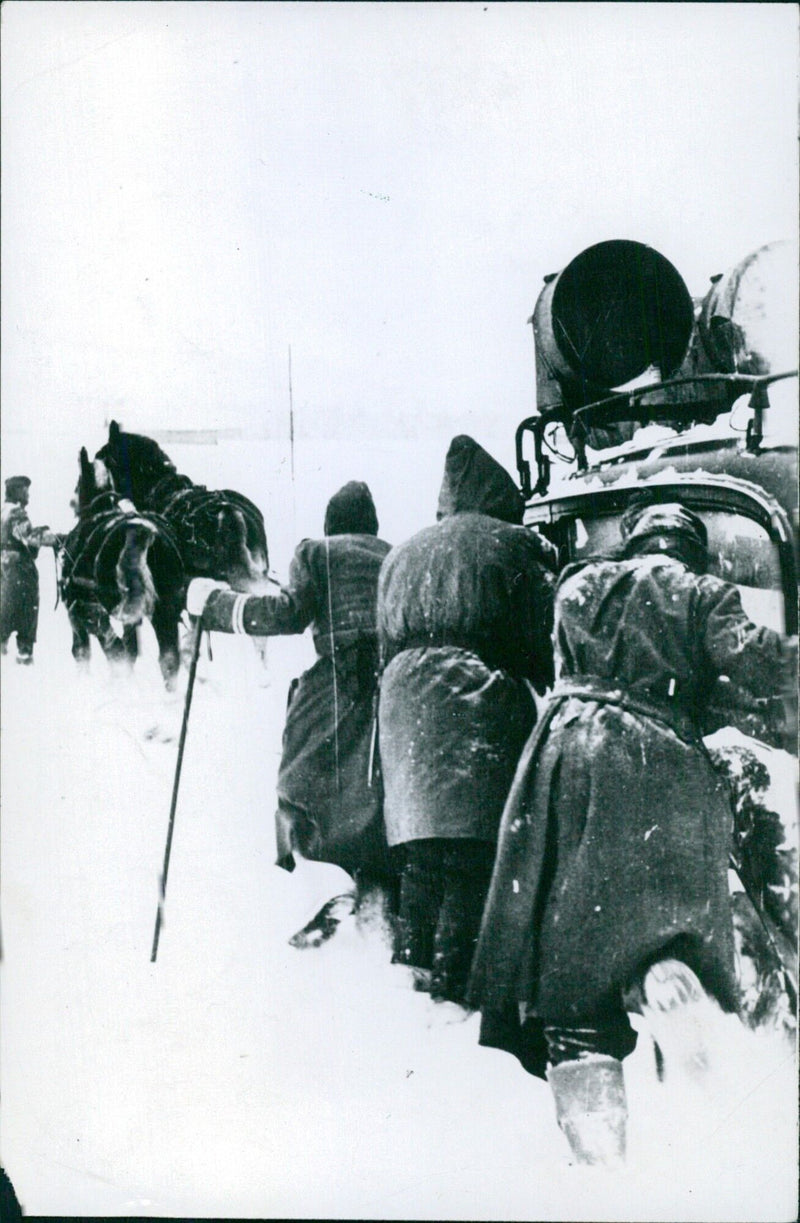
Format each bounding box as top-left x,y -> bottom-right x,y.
192,481 -> 391,919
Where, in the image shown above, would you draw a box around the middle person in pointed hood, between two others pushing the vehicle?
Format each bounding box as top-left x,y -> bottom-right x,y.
378,437 -> 553,1003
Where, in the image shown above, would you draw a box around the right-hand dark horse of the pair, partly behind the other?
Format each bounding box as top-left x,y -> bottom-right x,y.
95,421 -> 269,591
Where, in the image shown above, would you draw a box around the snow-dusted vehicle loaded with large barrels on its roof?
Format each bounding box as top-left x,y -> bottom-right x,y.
516,241 -> 798,1029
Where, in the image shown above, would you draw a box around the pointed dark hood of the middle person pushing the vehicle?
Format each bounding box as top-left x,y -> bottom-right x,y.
437,433 -> 525,525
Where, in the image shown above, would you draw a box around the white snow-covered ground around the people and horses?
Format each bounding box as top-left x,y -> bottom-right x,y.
0,452 -> 796,1223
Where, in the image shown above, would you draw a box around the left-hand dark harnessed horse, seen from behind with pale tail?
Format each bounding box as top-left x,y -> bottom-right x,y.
60,448 -> 186,687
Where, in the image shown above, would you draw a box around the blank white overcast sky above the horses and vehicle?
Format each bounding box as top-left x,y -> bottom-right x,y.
2,0 -> 798,445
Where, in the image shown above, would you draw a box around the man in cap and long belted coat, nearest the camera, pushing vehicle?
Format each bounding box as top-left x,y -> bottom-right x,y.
470,503 -> 796,1164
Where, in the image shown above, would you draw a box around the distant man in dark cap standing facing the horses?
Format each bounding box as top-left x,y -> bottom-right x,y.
0,476 -> 57,664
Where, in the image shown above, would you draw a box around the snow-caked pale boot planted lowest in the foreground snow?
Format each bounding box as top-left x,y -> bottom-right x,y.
547,1053 -> 628,1168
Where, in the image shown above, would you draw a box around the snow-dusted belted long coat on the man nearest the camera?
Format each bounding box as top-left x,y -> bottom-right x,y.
470,556 -> 796,1043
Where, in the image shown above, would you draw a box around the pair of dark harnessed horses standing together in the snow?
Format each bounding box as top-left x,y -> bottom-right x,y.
60,421 -> 270,689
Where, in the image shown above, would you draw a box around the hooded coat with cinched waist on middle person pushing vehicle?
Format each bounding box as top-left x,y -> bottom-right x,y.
378,439 -> 553,845
